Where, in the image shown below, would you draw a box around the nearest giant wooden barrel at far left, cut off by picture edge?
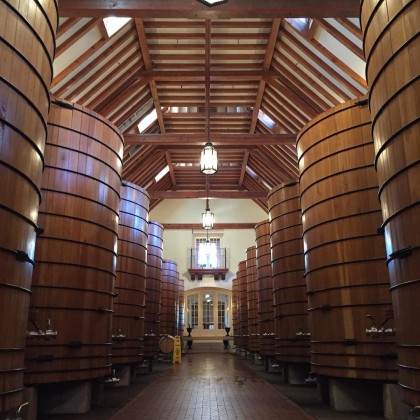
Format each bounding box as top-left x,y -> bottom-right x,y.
0,0 -> 58,417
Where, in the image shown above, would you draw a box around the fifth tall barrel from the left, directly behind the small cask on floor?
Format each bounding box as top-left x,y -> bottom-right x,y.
160,259 -> 179,336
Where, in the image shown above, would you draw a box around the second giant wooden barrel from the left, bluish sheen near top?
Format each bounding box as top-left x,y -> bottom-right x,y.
25,100 -> 123,384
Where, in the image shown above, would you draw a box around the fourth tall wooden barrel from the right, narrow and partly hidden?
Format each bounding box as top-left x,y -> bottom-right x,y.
255,220 -> 276,357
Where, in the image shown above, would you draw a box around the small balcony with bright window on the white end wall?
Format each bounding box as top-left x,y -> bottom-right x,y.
188,248 -> 229,280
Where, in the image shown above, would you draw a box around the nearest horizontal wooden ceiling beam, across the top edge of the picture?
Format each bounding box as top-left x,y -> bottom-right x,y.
59,0 -> 360,19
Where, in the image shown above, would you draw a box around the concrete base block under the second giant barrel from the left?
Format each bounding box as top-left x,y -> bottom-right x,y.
38,381 -> 92,414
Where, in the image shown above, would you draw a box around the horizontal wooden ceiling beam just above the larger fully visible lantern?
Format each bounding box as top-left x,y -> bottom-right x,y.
124,133 -> 296,146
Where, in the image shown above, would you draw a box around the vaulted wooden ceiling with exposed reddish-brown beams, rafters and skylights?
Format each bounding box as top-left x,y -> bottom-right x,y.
55,0 -> 367,210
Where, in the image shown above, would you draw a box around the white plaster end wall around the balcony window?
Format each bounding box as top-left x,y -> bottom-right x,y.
149,199 -> 268,290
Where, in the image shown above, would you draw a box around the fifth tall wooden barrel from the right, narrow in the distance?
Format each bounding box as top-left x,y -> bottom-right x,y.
246,246 -> 260,353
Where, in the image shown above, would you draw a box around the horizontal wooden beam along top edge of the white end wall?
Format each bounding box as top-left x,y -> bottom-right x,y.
148,189 -> 267,200
